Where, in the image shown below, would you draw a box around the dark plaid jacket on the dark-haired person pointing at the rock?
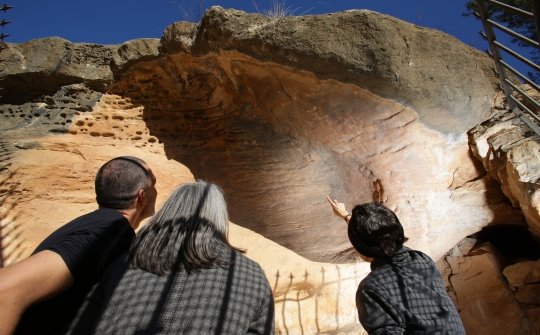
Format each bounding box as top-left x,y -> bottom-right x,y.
356,247 -> 465,334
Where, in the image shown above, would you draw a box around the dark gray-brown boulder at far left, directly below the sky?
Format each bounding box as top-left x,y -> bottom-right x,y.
0,37 -> 114,104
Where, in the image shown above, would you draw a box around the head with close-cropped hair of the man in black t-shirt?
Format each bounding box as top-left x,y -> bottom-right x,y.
95,156 -> 157,224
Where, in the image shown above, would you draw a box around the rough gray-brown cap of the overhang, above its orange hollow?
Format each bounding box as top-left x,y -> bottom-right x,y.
192,7 -> 497,133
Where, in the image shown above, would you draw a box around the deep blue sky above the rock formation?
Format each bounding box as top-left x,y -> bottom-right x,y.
4,0 -> 486,49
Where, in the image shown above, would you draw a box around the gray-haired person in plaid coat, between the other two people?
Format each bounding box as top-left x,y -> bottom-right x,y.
70,181 -> 274,335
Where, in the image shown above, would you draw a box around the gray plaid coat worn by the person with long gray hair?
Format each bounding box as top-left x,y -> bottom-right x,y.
70,250 -> 274,335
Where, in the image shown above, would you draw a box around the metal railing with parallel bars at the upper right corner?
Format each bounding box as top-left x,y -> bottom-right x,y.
474,0 -> 540,135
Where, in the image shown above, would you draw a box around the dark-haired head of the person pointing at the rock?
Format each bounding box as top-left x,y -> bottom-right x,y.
348,202 -> 407,258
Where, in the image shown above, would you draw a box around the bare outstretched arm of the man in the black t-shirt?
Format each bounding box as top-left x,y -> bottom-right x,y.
0,250 -> 73,335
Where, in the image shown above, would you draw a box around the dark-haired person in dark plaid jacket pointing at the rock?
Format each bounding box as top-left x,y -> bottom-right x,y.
328,197 -> 465,334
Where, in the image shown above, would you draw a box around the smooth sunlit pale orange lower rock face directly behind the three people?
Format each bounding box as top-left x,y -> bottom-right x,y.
0,117 -> 369,334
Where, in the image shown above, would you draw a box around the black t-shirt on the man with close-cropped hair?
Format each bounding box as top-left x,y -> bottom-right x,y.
15,208 -> 135,334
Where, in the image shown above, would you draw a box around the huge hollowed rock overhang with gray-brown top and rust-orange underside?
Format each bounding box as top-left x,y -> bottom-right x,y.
0,8 -> 515,262
